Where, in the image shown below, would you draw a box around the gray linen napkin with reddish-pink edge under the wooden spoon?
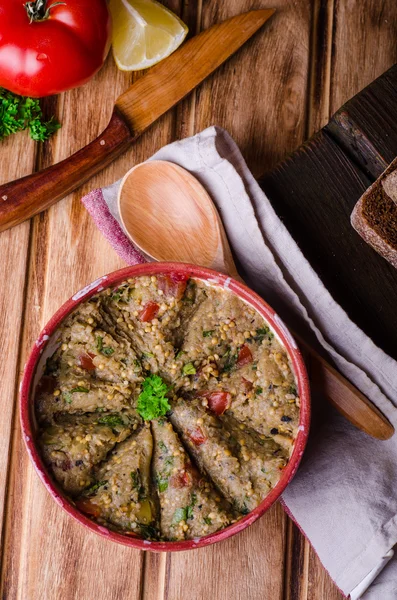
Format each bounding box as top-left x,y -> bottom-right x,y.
83,127 -> 397,600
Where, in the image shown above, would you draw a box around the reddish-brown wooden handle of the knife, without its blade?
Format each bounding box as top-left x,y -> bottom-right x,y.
0,109 -> 134,231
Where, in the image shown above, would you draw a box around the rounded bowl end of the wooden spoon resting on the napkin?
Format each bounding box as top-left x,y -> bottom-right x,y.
119,160 -> 239,279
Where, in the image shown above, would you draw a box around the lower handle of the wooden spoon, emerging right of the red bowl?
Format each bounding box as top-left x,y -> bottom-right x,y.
298,338 -> 394,440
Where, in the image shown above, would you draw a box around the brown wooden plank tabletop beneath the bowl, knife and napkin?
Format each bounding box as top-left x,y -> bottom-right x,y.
0,0 -> 397,600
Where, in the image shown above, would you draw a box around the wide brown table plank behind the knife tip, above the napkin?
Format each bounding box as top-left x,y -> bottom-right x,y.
190,0 -> 311,176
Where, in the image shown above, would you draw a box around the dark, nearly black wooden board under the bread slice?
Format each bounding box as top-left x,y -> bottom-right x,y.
259,66 -> 397,358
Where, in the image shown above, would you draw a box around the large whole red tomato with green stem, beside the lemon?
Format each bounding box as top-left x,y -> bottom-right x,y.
0,0 -> 111,98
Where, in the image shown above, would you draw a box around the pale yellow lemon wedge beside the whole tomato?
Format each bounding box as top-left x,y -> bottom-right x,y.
110,0 -> 188,71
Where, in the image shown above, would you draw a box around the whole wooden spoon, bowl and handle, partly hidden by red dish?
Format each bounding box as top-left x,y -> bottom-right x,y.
118,161 -> 394,440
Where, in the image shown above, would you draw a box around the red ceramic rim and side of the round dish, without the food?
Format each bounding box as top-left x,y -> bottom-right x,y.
20,263 -> 310,552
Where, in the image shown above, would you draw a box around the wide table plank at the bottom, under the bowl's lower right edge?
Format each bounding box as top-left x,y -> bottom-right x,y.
165,504 -> 286,600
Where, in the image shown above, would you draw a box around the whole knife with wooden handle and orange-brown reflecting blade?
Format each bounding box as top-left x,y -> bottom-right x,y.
0,9 -> 275,231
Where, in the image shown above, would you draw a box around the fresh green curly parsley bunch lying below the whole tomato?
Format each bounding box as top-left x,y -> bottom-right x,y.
0,88 -> 61,142
